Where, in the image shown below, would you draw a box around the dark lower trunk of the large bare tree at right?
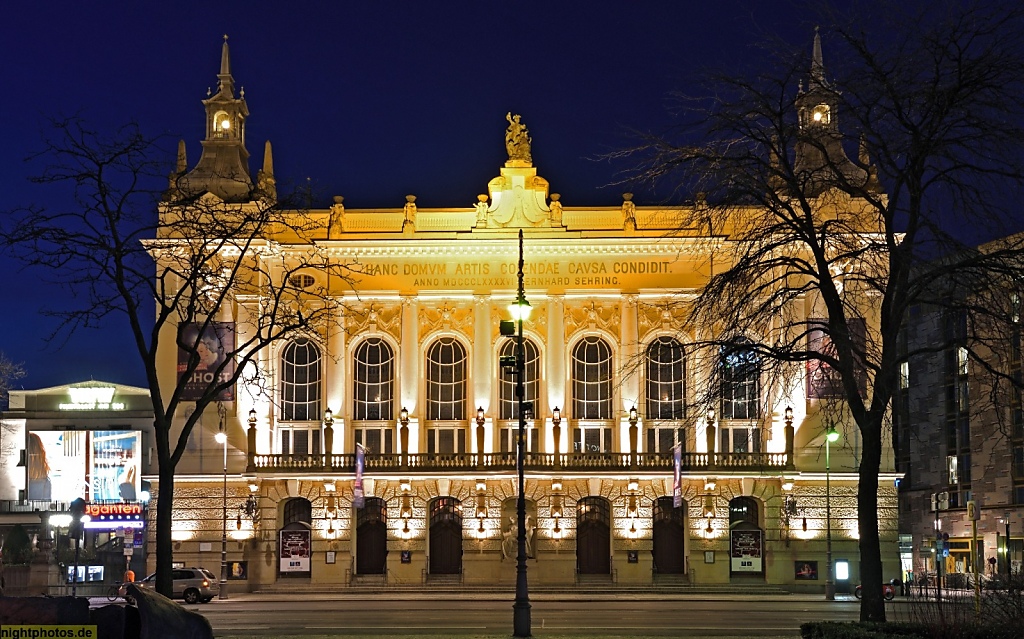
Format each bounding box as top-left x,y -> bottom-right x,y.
857,412 -> 886,622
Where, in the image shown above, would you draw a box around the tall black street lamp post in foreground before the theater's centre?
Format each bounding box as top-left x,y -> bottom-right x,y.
502,228 -> 530,637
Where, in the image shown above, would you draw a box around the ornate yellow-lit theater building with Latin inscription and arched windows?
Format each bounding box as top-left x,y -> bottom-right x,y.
151,37 -> 898,590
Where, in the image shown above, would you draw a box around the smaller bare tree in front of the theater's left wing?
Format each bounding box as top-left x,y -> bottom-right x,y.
0,120 -> 349,595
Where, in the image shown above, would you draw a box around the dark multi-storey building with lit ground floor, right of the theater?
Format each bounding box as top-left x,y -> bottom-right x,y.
893,287 -> 1024,586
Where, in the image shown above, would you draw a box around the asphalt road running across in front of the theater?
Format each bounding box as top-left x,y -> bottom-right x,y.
176,594 -> 872,637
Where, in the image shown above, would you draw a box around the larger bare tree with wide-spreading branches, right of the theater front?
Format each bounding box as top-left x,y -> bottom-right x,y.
620,2 -> 1024,621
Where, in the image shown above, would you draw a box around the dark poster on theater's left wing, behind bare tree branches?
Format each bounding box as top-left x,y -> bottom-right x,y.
178,322 -> 234,401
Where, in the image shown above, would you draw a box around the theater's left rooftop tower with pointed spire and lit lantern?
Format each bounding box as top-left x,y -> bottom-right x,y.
172,35 -> 256,202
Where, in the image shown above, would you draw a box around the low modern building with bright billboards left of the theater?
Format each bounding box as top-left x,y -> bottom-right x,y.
0,381 -> 156,594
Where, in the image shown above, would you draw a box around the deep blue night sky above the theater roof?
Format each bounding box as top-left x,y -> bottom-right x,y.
0,0 -> 828,388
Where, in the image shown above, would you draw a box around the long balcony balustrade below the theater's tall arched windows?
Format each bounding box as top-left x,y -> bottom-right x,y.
251,453 -> 788,475
